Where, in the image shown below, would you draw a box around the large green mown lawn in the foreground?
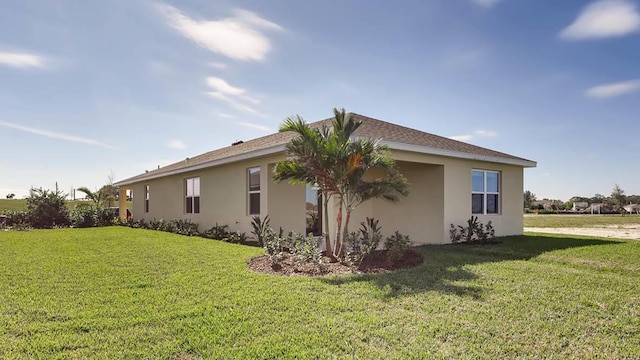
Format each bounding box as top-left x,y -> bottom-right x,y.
0,227 -> 640,359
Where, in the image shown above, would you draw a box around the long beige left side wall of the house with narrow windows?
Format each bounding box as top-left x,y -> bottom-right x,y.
131,156 -> 305,235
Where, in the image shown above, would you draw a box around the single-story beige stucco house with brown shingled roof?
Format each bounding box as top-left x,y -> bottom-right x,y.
115,113 -> 536,244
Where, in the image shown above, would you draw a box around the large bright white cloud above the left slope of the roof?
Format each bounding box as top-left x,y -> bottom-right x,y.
157,4 -> 283,61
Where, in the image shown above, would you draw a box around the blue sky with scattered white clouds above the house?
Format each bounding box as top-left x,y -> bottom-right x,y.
0,0 -> 640,200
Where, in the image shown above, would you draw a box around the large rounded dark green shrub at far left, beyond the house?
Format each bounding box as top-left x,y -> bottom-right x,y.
27,188 -> 69,229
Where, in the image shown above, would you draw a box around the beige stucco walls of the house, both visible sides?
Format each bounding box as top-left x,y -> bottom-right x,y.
124,151 -> 523,244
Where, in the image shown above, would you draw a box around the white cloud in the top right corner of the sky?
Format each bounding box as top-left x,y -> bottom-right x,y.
560,0 -> 640,40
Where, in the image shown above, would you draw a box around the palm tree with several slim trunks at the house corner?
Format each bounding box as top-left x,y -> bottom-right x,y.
274,108 -> 408,258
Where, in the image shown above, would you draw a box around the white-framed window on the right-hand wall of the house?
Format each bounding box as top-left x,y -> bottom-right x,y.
471,170 -> 500,214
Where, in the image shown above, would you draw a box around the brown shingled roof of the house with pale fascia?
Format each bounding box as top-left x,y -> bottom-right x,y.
115,113 -> 536,185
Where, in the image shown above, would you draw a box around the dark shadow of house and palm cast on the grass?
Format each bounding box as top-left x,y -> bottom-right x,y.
321,235 -> 621,300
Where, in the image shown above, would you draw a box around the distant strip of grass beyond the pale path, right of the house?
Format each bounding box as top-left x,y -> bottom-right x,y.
524,214 -> 640,228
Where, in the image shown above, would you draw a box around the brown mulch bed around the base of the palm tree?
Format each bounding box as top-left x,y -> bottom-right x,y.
248,250 -> 423,276
